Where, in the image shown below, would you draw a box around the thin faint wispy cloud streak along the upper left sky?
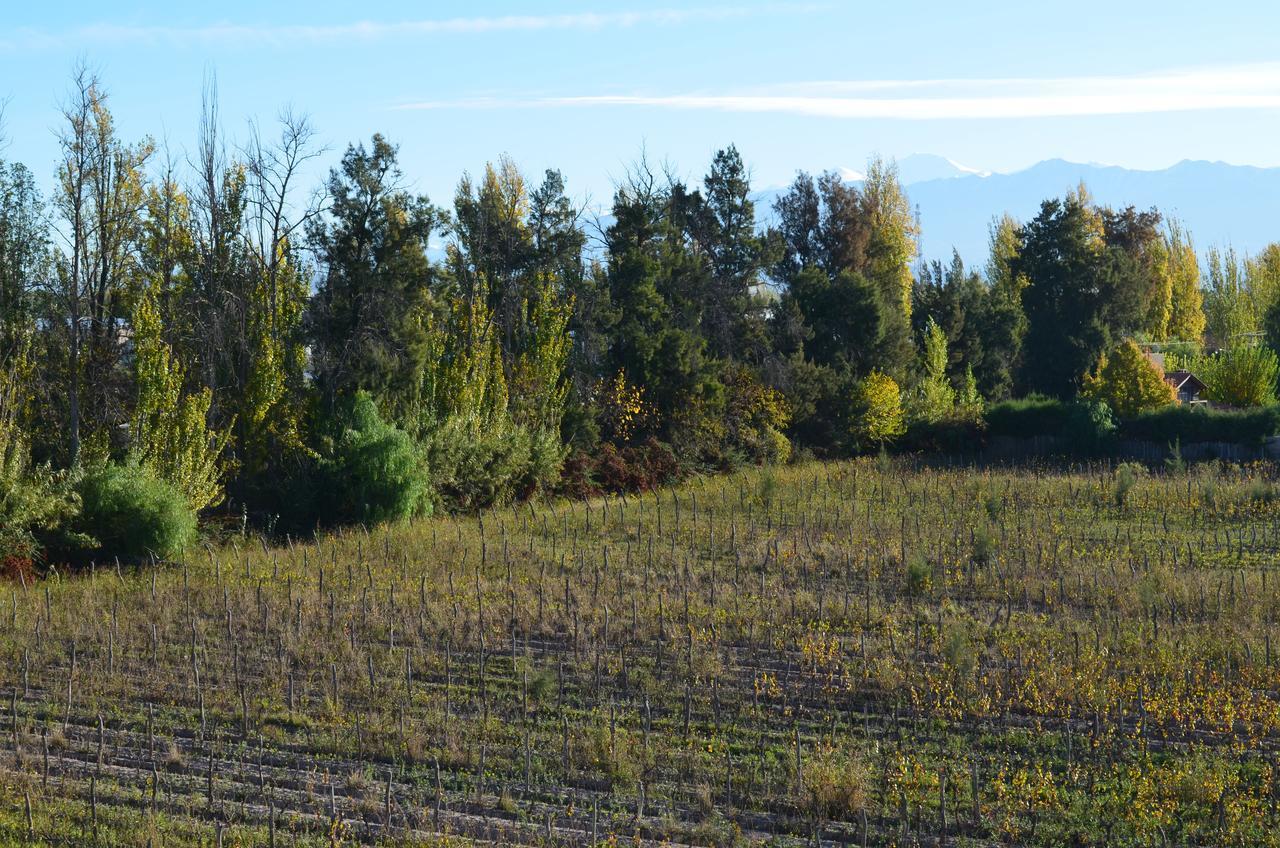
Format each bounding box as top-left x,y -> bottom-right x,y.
0,4 -> 829,51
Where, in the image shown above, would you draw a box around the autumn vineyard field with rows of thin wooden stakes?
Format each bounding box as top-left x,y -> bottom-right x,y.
0,457 -> 1280,848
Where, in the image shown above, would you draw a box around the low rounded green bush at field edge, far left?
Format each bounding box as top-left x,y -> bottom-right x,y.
76,465 -> 196,560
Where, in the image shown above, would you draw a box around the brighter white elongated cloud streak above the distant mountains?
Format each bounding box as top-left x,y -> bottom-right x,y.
399,63 -> 1280,120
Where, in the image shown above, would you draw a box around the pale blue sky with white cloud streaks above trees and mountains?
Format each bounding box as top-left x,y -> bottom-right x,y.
0,0 -> 1280,204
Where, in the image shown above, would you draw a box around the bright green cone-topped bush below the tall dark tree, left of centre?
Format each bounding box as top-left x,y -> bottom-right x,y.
321,393 -> 431,524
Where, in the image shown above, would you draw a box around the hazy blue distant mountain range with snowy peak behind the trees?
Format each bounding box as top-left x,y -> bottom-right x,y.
756,155 -> 1280,266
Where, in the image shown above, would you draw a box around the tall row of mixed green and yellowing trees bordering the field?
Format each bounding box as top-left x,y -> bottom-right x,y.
0,69 -> 1280,561
